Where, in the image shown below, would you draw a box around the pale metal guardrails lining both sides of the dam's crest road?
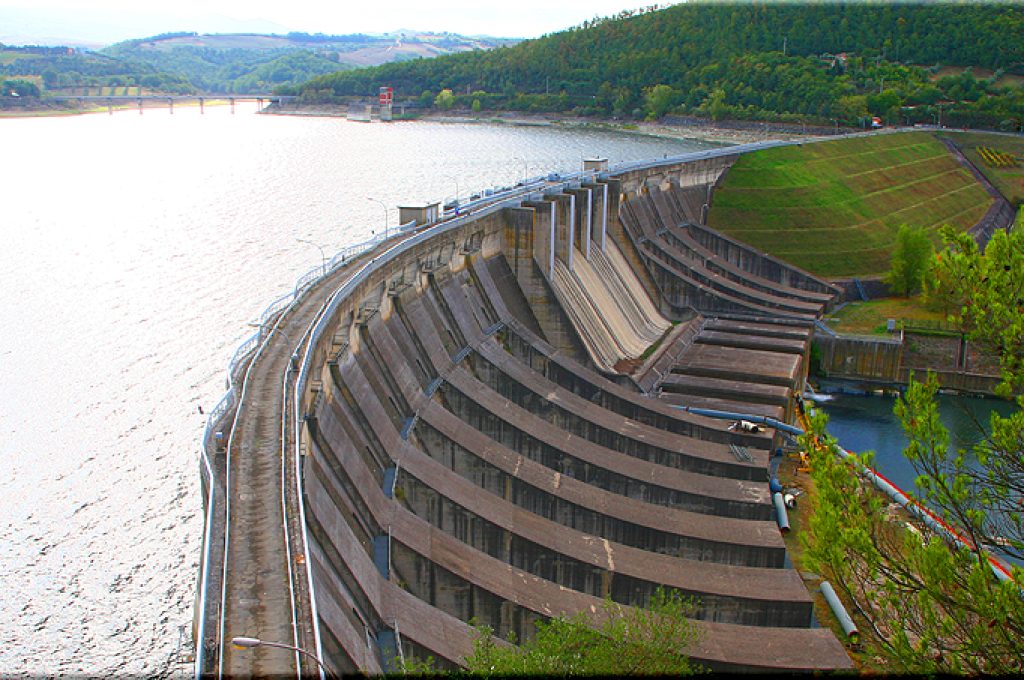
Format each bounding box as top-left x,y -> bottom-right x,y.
195,130 -> 892,680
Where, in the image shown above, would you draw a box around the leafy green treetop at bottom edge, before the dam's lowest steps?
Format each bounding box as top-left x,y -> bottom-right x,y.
466,589 -> 700,677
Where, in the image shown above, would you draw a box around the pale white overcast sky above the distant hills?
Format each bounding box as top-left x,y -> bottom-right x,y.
0,0 -> 669,44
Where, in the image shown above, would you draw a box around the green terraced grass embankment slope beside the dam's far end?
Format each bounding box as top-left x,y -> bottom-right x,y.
708,132 -> 991,278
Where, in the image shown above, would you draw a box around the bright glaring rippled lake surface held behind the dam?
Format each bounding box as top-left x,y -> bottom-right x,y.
0,105 -> 710,676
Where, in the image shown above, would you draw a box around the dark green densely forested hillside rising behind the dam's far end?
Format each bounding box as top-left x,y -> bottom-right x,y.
289,3 -> 1024,126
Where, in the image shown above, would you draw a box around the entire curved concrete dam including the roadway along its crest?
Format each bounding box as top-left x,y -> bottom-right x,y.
197,144 -> 852,675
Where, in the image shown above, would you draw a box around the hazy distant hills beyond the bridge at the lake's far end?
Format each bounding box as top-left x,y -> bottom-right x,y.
0,32 -> 515,98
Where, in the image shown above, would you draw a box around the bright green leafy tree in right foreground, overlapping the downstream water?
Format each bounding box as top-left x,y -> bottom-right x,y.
804,214 -> 1024,674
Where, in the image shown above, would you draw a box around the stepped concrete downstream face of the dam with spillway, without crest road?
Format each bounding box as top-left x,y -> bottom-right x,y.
286,159 -> 850,673
